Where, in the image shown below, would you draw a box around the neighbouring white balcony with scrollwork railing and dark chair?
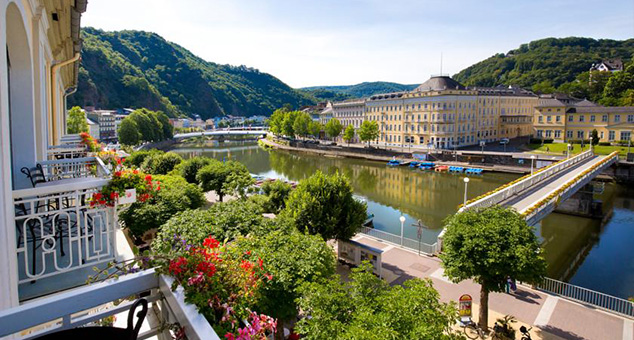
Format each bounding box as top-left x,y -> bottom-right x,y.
13,157 -> 119,300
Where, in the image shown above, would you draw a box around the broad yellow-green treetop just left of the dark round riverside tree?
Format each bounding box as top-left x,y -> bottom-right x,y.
152,200 -> 273,254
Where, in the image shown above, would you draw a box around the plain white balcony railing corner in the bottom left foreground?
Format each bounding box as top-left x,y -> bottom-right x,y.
0,269 -> 219,340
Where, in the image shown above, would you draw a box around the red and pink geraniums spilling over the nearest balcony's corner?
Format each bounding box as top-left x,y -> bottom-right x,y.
161,236 -> 276,340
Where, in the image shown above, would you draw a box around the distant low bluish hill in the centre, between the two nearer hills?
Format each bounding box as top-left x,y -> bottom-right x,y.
301,81 -> 419,100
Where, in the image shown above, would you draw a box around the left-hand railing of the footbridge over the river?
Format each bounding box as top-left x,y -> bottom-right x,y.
458,150 -> 593,212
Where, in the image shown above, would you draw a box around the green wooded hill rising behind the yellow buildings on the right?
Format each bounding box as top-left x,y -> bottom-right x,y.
453,37 -> 634,88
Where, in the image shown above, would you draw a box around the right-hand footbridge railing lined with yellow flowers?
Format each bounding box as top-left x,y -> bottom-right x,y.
521,151 -> 619,224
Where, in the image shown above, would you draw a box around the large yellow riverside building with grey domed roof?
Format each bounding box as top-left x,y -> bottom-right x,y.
365,76 -> 537,148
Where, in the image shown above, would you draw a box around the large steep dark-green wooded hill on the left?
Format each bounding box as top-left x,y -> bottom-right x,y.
68,27 -> 315,118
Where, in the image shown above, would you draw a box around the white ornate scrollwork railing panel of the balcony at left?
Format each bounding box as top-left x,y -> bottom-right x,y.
13,178 -> 116,283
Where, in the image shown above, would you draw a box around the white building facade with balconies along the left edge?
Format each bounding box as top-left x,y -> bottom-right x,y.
0,0 -> 219,339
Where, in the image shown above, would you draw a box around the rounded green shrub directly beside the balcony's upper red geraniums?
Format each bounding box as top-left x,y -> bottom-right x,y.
119,175 -> 205,237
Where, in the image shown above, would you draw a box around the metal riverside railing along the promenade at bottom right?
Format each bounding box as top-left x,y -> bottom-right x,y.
537,278 -> 634,318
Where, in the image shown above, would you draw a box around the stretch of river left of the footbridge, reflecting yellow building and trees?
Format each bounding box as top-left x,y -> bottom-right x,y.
174,143 -> 517,243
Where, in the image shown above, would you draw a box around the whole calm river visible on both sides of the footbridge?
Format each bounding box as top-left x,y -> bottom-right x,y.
168,141 -> 634,298
